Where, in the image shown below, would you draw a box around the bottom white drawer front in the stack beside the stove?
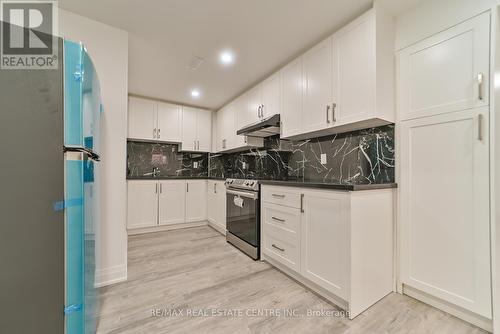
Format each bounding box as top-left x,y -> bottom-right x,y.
262,224 -> 300,273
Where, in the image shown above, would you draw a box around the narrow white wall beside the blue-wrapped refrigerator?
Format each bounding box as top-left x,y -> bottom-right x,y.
59,9 -> 128,286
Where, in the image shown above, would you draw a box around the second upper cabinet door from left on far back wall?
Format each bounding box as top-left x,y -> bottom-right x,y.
157,102 -> 182,143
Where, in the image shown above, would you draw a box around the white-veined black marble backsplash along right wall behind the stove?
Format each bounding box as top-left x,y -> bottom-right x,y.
209,125 -> 395,184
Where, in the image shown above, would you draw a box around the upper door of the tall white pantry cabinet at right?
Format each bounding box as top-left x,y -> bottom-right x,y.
399,12 -> 490,120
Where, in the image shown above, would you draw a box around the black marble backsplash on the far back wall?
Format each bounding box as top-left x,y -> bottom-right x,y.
127,141 -> 208,178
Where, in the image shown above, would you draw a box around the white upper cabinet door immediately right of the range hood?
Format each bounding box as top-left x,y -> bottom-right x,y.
281,58 -> 304,137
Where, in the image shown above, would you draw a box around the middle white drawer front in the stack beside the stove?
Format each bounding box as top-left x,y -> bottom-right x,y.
262,203 -> 300,233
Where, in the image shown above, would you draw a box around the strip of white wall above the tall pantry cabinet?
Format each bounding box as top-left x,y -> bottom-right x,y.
395,0 -> 496,50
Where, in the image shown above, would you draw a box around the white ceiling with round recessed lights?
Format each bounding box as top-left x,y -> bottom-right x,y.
59,0 -> 415,109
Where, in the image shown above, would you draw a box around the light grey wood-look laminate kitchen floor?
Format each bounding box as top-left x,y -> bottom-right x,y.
98,226 -> 486,334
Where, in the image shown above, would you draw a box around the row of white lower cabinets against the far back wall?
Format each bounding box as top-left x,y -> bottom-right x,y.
127,180 -> 207,230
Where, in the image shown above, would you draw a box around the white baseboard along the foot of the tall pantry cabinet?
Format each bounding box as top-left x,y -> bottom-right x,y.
403,284 -> 493,332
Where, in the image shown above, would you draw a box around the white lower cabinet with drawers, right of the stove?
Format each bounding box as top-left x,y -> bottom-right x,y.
261,185 -> 394,319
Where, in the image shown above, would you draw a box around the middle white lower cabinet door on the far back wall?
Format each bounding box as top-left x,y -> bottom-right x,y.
158,180 -> 186,225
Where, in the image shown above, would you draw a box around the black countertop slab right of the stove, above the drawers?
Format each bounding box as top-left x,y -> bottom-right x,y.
260,180 -> 398,191
